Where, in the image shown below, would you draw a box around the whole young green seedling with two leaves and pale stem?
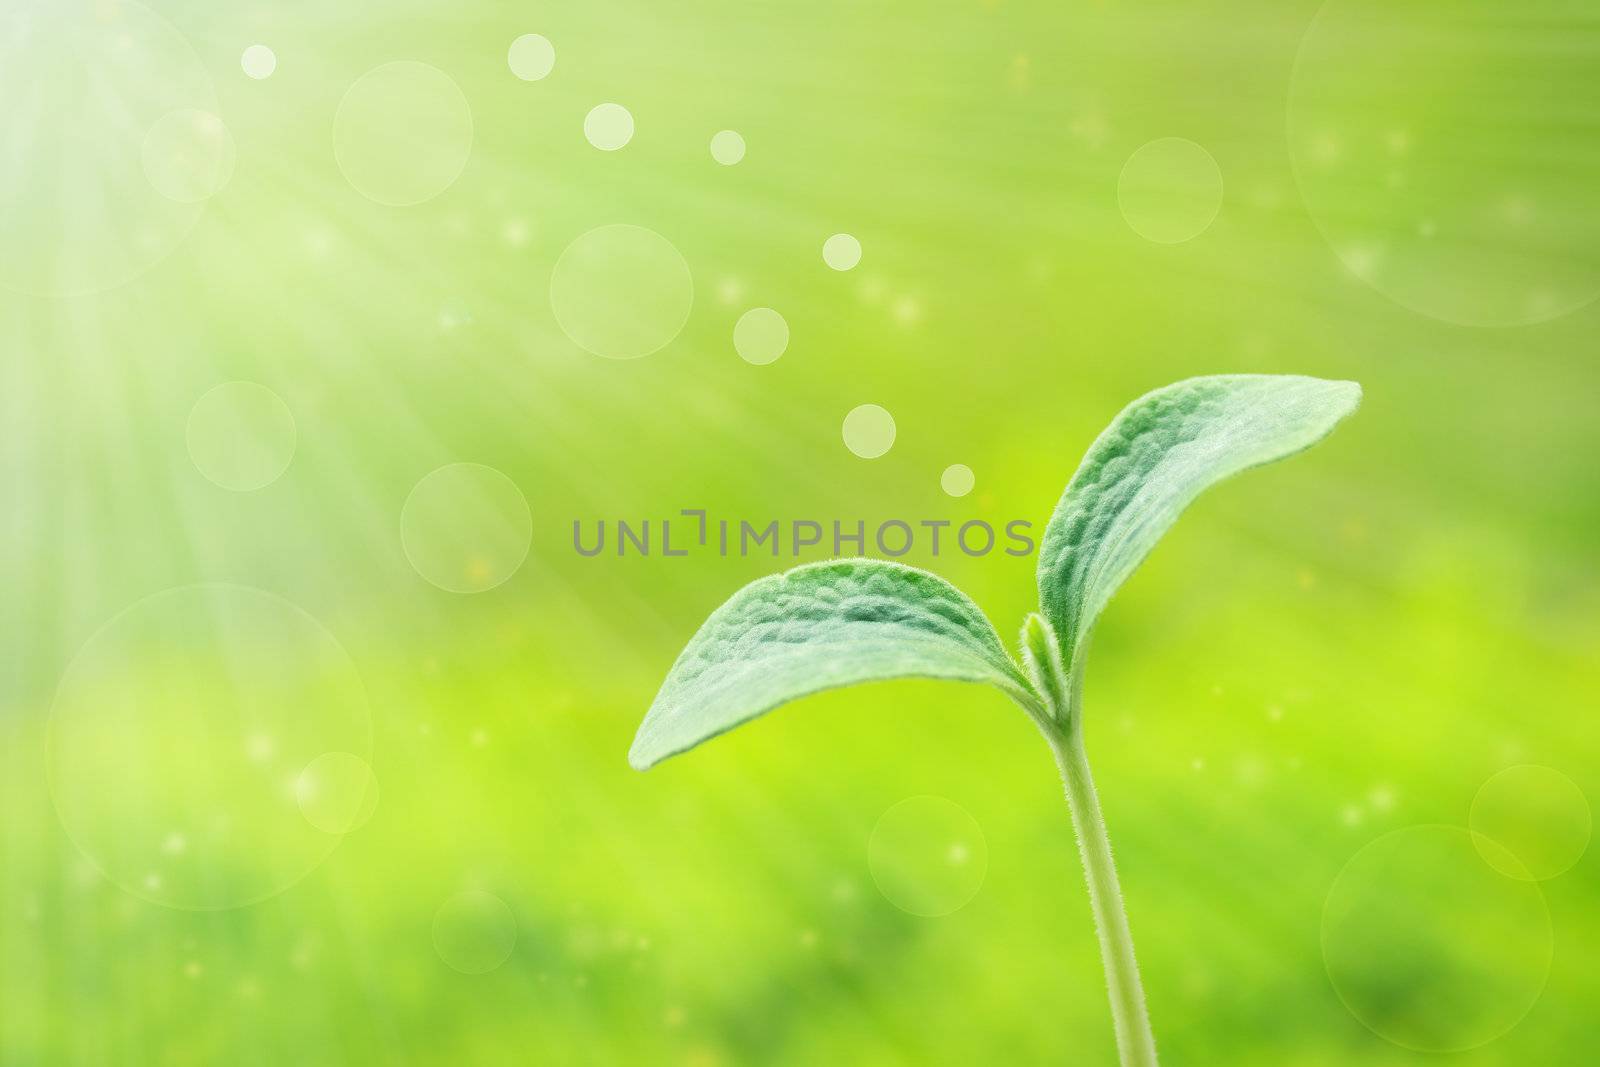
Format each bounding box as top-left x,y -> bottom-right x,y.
627,374 -> 1362,1067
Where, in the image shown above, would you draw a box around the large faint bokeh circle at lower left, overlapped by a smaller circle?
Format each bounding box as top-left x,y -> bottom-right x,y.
46,584 -> 371,909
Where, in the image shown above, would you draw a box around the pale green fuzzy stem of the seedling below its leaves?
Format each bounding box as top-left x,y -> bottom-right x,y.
1045,713 -> 1157,1067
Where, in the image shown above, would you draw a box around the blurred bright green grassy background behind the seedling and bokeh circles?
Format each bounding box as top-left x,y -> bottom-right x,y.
0,0 -> 1600,1067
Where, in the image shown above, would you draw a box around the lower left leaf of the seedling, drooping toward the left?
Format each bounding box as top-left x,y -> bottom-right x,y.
627,560 -> 1034,771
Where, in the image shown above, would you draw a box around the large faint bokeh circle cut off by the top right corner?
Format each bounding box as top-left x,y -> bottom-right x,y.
1288,0 -> 1600,326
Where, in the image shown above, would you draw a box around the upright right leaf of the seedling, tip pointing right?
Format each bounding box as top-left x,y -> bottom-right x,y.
1038,374 -> 1362,669
